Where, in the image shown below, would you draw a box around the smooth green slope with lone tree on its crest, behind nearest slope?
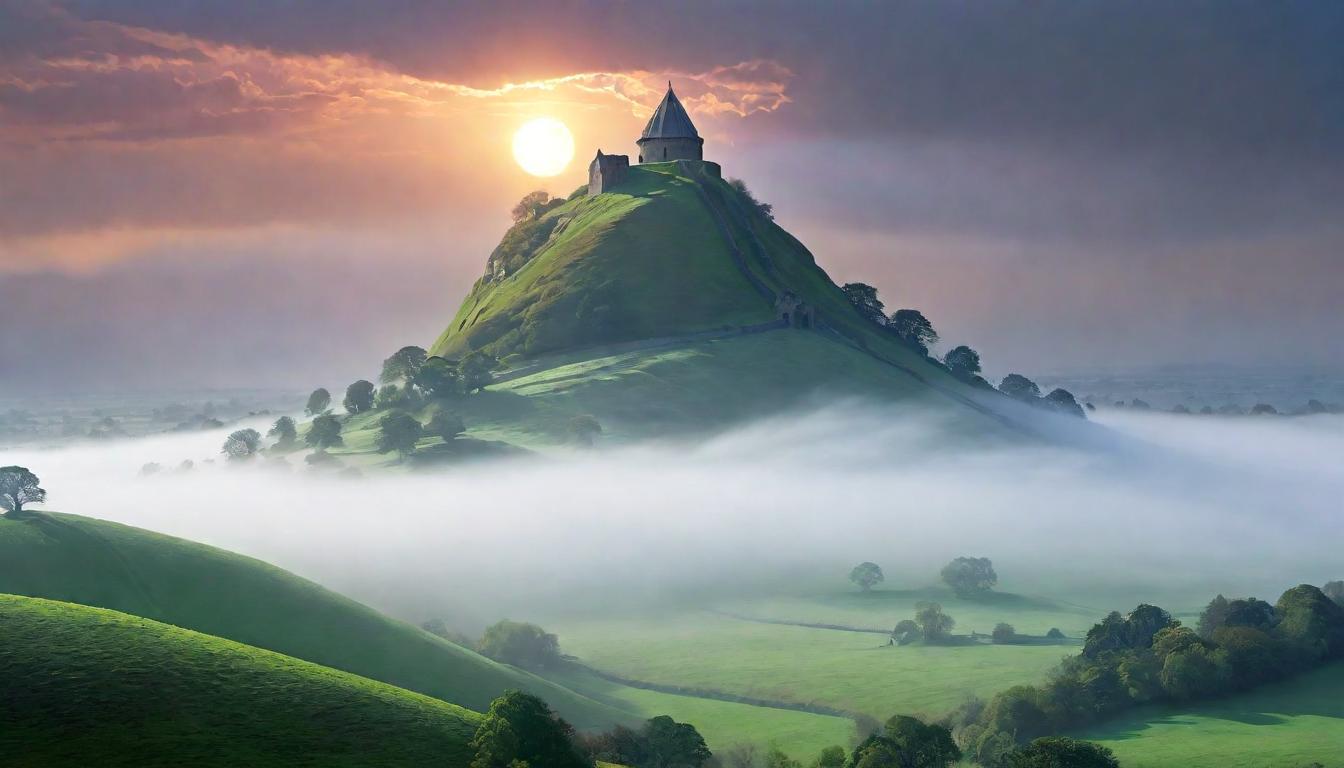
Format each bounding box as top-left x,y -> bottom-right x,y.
0,512 -> 629,726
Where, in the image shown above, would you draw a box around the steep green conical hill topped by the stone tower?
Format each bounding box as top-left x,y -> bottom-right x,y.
424,160 -> 1024,444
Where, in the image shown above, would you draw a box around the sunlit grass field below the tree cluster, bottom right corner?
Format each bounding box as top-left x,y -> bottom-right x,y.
1079,663 -> 1344,768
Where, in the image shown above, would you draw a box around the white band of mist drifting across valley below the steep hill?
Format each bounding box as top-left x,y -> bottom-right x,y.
0,404 -> 1344,629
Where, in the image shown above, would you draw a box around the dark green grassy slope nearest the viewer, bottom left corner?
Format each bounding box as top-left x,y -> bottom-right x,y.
0,594 -> 480,768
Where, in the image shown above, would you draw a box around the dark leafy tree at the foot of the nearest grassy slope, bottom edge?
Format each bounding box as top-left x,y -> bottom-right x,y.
469,690 -> 591,768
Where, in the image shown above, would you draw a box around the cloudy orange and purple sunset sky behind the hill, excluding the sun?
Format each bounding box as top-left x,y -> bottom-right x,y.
0,0 -> 1344,393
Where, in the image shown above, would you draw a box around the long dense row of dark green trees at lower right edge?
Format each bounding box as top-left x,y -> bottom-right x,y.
950,584 -> 1344,768
